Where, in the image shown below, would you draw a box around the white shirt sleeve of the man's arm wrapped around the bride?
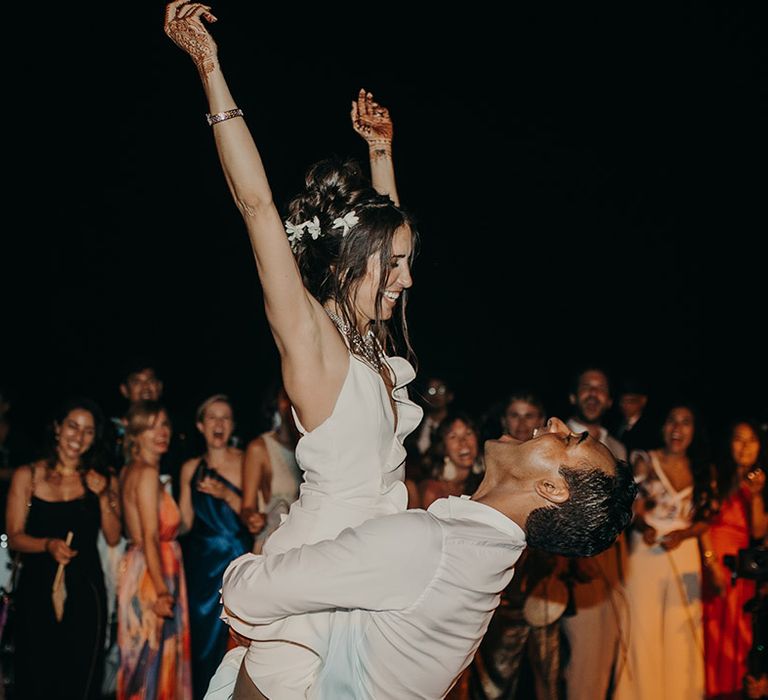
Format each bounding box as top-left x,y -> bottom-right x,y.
222,511 -> 443,625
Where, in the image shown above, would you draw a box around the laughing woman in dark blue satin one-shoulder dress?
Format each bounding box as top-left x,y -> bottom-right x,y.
179,394 -> 253,698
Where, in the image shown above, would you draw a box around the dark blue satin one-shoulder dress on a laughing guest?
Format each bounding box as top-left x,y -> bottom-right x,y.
183,458 -> 251,698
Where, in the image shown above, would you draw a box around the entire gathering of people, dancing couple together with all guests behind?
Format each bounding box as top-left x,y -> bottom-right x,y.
0,0 -> 768,700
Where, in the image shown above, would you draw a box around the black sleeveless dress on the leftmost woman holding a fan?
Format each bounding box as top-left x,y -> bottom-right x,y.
14,487 -> 106,700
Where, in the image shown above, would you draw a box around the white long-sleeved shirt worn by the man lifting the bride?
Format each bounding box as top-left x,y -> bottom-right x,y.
222,496 -> 525,700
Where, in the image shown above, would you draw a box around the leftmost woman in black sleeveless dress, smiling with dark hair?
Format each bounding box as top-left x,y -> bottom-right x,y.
6,399 -> 120,700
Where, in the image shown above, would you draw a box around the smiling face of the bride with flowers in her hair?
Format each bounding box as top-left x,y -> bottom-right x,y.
354,225 -> 413,327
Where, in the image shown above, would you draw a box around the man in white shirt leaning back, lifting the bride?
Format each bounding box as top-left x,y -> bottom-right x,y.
213,418 -> 635,700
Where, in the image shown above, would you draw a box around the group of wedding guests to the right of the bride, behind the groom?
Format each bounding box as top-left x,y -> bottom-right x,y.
410,368 -> 768,700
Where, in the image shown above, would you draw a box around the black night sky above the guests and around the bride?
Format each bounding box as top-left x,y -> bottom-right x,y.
0,0 -> 768,448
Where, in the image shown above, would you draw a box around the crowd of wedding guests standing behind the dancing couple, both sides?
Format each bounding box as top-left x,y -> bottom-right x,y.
0,362 -> 768,700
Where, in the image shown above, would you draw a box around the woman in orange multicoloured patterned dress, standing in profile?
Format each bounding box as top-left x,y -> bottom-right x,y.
117,401 -> 192,700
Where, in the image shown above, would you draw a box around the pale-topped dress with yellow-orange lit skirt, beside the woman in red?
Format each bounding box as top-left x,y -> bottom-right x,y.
614,452 -> 704,700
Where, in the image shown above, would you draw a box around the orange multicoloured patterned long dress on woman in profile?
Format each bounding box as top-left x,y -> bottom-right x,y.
117,488 -> 192,700
